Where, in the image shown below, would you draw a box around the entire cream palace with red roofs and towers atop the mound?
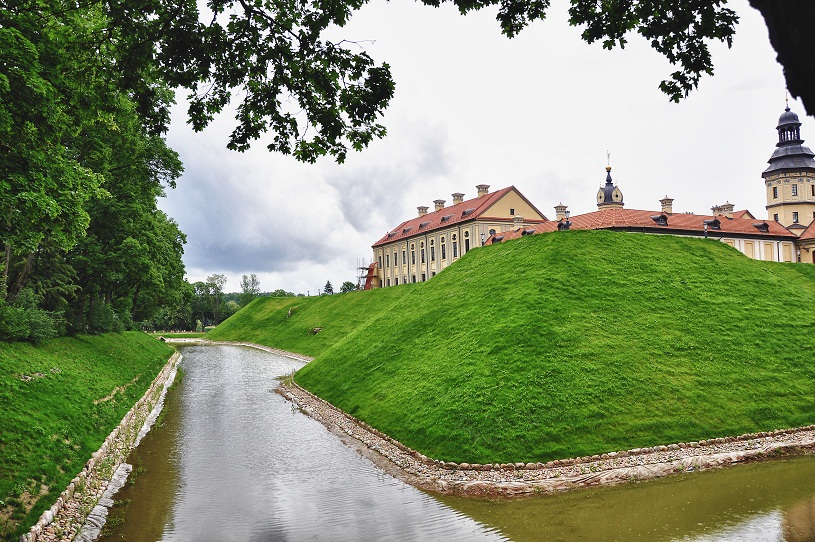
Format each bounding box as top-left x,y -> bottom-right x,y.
365,103 -> 815,289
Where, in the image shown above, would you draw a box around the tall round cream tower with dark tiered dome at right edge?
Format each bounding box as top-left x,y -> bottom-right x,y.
761,105 -> 815,233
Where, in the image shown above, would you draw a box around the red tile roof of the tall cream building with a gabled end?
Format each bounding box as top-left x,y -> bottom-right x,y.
371,186 -> 546,247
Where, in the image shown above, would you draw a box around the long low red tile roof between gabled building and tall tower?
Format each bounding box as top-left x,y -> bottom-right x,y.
488,208 -> 792,245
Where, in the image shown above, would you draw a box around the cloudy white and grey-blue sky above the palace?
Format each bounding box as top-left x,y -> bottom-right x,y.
159,0 -> 815,295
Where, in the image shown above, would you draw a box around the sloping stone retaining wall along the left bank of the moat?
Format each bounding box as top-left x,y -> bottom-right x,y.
20,352 -> 181,542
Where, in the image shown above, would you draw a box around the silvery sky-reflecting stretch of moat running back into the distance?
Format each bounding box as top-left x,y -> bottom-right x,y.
102,346 -> 504,542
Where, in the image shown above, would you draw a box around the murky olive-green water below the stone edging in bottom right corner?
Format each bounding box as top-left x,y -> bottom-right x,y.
440,457 -> 815,542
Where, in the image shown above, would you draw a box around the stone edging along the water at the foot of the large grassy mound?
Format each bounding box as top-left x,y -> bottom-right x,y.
278,381 -> 815,496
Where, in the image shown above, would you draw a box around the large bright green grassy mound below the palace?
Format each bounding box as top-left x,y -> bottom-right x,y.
207,231 -> 815,463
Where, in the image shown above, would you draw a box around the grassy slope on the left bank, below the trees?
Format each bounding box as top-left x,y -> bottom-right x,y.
0,332 -> 173,538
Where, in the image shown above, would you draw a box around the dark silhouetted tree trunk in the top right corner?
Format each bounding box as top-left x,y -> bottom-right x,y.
750,0 -> 815,116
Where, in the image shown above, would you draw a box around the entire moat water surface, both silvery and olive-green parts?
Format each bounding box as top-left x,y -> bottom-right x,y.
104,346 -> 815,542
